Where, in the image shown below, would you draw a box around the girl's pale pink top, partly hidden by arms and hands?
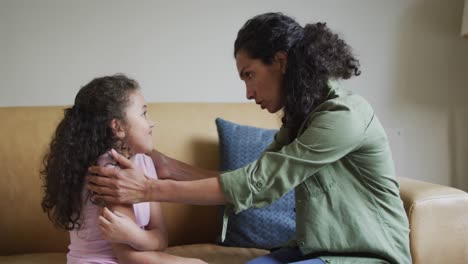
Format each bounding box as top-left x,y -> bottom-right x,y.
67,154 -> 157,264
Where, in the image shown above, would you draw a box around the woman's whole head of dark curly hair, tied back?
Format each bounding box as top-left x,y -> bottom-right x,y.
234,13 -> 361,140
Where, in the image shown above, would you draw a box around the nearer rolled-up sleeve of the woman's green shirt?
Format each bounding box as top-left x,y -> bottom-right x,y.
220,108 -> 369,213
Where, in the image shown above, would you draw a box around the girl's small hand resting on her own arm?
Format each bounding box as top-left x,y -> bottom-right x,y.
98,207 -> 141,247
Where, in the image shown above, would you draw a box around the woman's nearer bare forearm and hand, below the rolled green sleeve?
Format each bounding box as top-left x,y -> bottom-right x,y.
86,153 -> 226,205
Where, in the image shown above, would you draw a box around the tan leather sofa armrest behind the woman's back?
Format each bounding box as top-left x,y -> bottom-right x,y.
399,178 -> 468,264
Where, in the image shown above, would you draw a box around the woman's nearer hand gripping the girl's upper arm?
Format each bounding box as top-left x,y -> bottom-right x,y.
86,150 -> 149,204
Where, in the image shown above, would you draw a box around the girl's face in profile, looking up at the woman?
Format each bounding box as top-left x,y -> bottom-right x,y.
119,90 -> 154,154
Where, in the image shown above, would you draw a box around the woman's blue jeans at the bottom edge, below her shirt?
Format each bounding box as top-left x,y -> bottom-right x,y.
246,248 -> 325,264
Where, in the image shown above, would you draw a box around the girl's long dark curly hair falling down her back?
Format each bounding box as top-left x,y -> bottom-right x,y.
41,74 -> 139,230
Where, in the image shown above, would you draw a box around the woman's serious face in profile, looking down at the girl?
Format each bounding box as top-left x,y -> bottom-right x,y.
236,50 -> 287,113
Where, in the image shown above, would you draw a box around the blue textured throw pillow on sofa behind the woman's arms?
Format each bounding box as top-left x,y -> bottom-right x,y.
216,118 -> 296,249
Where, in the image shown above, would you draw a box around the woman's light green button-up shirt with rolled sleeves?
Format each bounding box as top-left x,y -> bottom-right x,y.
221,84 -> 411,263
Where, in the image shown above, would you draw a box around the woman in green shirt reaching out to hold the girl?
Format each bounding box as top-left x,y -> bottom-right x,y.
89,13 -> 411,263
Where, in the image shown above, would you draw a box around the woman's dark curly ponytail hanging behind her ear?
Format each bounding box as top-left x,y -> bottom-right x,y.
282,23 -> 361,141
